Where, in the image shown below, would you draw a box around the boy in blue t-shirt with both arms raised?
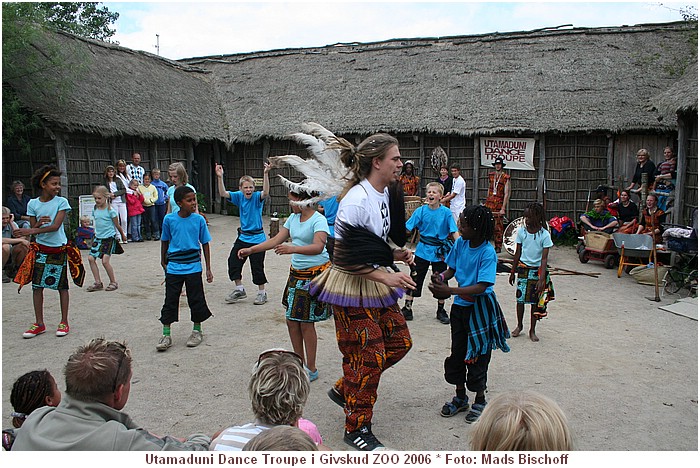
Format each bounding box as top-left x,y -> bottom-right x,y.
214,163 -> 272,305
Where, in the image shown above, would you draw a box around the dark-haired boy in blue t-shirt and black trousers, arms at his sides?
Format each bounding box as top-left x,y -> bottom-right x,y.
156,185 -> 214,351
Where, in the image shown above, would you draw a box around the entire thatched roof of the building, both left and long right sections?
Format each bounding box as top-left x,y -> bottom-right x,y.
3,22 -> 697,144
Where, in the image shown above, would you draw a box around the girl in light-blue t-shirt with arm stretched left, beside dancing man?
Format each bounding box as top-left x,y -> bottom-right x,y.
238,192 -> 331,382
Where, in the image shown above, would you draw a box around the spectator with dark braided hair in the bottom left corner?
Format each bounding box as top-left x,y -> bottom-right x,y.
2,369 -> 61,450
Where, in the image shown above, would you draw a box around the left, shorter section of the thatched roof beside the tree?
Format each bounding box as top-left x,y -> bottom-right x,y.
3,27 -> 226,141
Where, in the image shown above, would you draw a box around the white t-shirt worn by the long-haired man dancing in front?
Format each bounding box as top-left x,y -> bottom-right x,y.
335,179 -> 391,241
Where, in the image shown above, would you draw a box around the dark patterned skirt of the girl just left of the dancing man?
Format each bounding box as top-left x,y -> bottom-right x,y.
282,262 -> 332,323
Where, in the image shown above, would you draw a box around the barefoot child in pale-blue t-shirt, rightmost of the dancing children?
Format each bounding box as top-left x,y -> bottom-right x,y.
508,203 -> 554,341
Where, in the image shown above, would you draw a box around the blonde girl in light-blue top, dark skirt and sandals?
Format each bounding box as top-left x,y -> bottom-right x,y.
87,186 -> 127,292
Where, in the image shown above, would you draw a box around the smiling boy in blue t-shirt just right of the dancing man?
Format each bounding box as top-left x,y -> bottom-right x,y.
401,182 -> 458,324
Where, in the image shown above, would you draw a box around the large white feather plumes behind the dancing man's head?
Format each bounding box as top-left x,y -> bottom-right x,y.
269,122 -> 352,206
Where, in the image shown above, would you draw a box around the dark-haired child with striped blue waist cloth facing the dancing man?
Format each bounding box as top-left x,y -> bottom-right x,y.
429,205 -> 510,424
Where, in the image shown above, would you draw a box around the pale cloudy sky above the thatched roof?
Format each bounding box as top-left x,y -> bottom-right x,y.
104,0 -> 697,59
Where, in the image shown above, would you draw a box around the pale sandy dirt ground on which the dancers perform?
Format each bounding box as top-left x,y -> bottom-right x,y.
2,215 -> 698,451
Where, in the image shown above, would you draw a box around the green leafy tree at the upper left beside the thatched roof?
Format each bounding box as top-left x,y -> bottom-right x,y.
2,2 -> 119,153
